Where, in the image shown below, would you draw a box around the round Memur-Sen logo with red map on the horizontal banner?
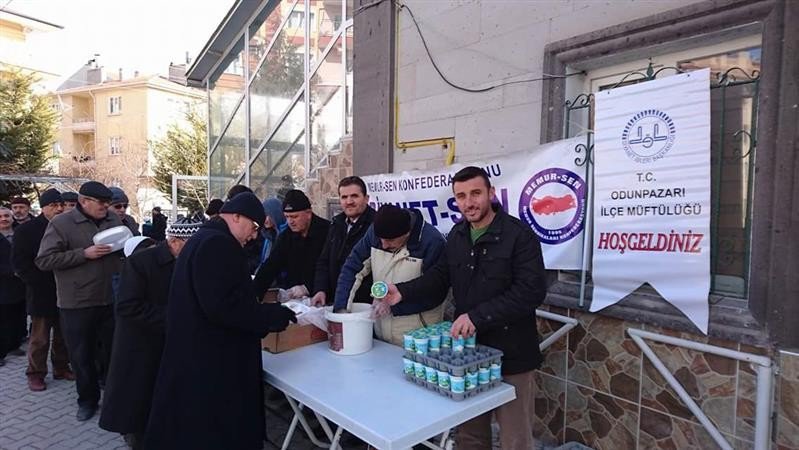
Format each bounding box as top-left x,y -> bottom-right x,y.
519,167 -> 586,245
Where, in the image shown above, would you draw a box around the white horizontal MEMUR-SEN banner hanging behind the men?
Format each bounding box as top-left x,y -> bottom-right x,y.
363,137 -> 587,269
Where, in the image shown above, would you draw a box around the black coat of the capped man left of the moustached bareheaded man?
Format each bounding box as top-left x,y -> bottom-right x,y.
255,214 -> 330,298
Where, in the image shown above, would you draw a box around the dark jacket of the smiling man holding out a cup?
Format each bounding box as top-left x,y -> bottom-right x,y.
397,208 -> 546,375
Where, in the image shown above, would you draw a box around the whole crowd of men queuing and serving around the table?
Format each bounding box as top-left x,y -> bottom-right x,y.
0,167 -> 546,449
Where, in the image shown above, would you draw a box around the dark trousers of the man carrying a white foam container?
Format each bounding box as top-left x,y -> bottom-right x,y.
59,305 -> 114,407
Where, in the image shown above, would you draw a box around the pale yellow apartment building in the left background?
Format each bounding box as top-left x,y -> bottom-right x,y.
53,70 -> 205,219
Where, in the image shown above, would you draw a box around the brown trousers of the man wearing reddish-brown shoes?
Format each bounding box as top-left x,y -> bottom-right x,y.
25,316 -> 69,378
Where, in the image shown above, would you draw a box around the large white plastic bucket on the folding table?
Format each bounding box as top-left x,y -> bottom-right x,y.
325,303 -> 374,355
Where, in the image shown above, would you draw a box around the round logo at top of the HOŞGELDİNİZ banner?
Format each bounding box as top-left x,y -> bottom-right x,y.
621,109 -> 675,164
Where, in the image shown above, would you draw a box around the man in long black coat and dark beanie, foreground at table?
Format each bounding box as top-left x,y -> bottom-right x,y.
143,192 -> 296,450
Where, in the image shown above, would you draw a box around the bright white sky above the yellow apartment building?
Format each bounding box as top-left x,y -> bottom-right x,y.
8,0 -> 234,78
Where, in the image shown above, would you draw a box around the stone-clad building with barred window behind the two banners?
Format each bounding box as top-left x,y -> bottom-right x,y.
189,0 -> 799,449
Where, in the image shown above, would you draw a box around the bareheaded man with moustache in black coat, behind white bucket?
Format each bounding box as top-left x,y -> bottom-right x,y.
311,177 -> 375,306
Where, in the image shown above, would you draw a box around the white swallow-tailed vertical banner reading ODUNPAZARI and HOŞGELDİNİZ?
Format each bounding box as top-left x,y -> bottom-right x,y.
591,70 -> 710,334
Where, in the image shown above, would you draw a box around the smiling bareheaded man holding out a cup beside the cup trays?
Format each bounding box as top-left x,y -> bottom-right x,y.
385,167 -> 546,450
